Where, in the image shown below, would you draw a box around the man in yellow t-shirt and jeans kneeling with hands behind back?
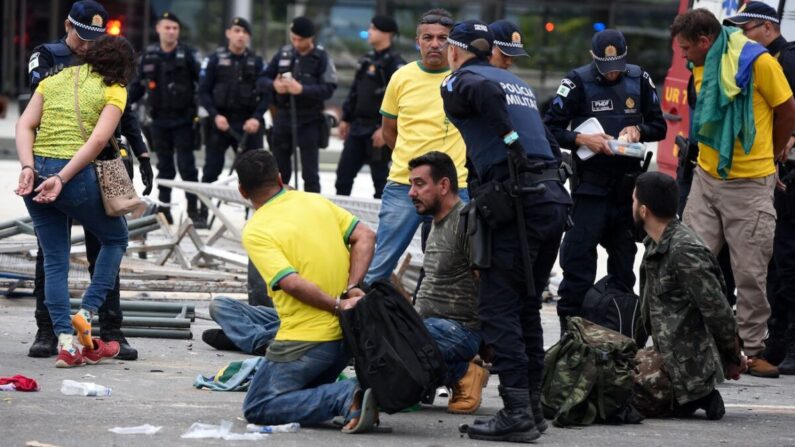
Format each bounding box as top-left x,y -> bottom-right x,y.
235,151 -> 377,432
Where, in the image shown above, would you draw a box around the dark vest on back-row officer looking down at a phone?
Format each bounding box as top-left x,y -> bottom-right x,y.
275,45 -> 328,114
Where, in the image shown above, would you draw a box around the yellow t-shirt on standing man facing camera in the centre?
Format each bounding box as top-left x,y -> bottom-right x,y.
381,61 -> 467,187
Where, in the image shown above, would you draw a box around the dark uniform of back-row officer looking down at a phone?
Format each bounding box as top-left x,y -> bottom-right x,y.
257,45 -> 337,192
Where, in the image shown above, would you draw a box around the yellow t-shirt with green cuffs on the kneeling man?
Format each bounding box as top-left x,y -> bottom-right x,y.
242,190 -> 359,342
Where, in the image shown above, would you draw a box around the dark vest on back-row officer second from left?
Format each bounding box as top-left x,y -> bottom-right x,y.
213,48 -> 258,115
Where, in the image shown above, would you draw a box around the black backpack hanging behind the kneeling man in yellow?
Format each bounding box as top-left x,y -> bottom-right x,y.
340,280 -> 447,414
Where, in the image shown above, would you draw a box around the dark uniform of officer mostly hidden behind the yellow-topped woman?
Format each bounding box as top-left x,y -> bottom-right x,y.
28,38 -> 148,360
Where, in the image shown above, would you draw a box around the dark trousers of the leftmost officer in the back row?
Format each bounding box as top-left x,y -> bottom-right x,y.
150,122 -> 199,210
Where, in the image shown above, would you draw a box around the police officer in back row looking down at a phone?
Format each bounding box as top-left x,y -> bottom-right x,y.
257,17 -> 337,192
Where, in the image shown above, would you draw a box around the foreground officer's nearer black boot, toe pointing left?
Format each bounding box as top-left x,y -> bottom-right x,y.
467,385 -> 541,443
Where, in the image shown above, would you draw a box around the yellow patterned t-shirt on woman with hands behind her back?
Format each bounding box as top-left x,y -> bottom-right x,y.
33,65 -> 127,159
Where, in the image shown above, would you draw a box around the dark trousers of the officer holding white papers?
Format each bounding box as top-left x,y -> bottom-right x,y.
558,185 -> 638,316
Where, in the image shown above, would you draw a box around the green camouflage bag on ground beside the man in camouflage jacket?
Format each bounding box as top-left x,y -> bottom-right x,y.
541,317 -> 643,427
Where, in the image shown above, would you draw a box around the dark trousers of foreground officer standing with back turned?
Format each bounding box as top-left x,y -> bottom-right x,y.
478,182 -> 569,390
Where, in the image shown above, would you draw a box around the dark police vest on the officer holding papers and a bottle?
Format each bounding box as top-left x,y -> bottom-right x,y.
571,64 -> 643,138
